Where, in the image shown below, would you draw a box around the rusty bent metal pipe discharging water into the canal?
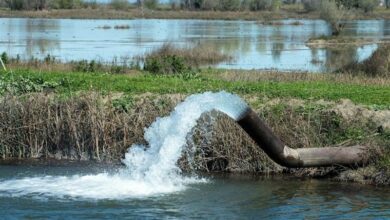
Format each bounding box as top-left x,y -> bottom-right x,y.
237,108 -> 368,168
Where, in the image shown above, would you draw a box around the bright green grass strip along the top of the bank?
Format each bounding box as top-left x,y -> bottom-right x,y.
0,70 -> 390,109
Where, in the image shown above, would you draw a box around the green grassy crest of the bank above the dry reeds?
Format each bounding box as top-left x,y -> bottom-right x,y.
2,70 -> 390,109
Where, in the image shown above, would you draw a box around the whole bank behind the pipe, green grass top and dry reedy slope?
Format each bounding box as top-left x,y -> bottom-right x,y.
0,68 -> 390,184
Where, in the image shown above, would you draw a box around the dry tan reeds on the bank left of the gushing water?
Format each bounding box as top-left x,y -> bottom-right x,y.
0,94 -> 173,161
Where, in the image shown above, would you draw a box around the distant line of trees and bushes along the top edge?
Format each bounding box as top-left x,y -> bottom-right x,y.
0,0 -> 384,12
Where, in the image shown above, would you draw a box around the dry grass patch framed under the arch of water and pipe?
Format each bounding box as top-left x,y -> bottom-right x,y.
180,112 -> 283,174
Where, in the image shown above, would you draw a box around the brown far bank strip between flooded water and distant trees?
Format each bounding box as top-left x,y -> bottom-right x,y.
0,8 -> 390,21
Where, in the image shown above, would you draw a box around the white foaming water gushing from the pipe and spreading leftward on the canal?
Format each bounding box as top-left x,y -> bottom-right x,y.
0,92 -> 248,199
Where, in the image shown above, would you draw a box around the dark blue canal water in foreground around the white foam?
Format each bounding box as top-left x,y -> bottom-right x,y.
0,166 -> 390,219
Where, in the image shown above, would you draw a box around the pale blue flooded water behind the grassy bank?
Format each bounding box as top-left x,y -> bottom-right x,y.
0,18 -> 390,71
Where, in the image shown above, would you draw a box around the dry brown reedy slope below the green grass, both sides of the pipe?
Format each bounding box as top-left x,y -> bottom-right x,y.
0,92 -> 390,183
